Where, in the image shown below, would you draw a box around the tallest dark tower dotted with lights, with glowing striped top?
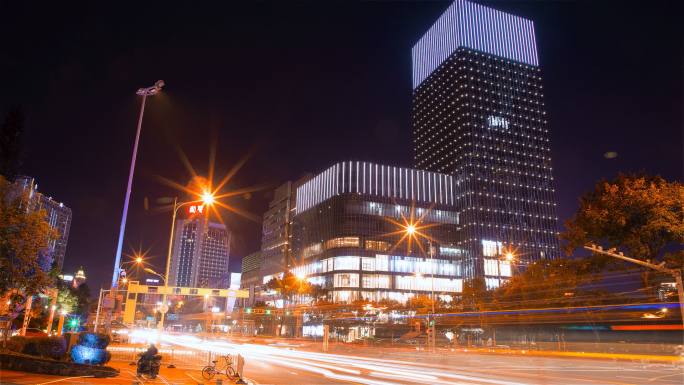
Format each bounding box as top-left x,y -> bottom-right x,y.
412,0 -> 559,287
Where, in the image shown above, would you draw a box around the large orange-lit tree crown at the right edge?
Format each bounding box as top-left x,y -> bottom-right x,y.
561,175 -> 684,296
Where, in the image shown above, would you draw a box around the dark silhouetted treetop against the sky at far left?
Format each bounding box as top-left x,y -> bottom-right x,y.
0,107 -> 24,180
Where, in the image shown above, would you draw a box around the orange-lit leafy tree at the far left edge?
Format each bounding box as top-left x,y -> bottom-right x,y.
0,177 -> 57,297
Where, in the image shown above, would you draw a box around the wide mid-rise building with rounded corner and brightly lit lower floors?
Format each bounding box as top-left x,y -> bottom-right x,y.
291,161 -> 488,302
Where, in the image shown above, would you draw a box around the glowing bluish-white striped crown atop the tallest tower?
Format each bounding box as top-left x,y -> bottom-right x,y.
412,0 -> 539,88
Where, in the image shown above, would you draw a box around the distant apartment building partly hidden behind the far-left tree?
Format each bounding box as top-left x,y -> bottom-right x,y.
14,176 -> 71,271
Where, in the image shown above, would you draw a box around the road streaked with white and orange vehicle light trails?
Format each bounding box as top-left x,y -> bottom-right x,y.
0,336 -> 684,385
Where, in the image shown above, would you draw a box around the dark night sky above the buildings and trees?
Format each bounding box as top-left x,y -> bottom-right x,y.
0,1 -> 684,289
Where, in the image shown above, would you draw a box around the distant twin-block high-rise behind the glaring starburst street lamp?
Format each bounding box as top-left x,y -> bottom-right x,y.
169,215 -> 231,287
